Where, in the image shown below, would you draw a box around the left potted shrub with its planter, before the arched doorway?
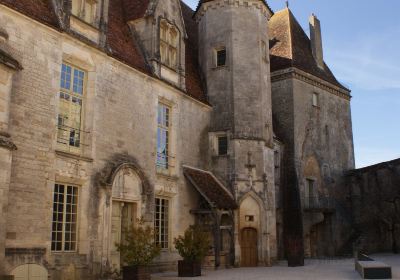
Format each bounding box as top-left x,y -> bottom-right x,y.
116,221 -> 161,280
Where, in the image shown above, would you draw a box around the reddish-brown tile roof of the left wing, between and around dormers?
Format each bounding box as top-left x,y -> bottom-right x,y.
0,0 -> 208,104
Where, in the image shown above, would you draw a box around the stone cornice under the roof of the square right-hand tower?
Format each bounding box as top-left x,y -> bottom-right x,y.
271,67 -> 351,100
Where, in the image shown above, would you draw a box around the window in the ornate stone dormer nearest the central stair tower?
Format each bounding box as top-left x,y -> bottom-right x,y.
160,20 -> 179,69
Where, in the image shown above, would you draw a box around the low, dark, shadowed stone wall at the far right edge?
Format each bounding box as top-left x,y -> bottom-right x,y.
347,159 -> 400,254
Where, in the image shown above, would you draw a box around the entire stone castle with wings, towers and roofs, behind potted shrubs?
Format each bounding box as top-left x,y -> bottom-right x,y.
0,0 -> 396,279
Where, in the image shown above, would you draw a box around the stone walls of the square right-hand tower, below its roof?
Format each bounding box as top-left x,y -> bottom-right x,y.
272,69 -> 354,256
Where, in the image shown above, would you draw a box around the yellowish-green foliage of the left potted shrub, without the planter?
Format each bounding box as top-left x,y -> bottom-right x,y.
116,220 -> 161,266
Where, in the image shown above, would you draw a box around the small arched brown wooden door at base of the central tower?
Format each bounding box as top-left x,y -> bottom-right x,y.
241,228 -> 258,267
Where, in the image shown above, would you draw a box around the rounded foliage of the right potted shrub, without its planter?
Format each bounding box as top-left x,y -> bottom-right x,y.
174,226 -> 210,262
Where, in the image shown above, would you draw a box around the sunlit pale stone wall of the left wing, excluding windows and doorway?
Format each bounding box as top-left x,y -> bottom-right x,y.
0,6 -> 210,279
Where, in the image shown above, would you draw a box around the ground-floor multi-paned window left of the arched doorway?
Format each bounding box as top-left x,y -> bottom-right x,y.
51,184 -> 78,252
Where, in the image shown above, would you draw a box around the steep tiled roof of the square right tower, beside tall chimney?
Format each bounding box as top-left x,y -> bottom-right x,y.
269,9 -> 348,90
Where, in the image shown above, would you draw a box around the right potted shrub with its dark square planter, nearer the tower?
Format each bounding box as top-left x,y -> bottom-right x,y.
174,226 -> 210,277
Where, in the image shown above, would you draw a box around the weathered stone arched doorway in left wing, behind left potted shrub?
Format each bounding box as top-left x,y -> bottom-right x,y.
96,155 -> 154,275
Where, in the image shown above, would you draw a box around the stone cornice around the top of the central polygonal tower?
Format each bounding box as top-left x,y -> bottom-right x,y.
195,0 -> 272,21
